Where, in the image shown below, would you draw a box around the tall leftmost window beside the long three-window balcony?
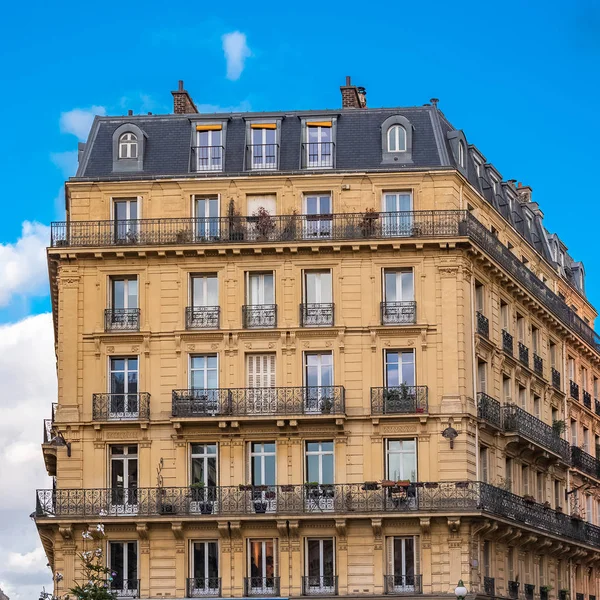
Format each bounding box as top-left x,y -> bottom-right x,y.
108,356 -> 140,420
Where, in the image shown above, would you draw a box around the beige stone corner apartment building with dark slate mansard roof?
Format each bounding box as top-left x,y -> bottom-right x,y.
36,78 -> 600,600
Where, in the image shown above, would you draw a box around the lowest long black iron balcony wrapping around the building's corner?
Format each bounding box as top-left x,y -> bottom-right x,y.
35,481 -> 600,547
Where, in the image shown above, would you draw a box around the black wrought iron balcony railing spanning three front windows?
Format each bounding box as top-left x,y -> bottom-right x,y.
172,385 -> 345,418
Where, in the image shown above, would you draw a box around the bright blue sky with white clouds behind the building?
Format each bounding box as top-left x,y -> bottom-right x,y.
0,0 -> 600,600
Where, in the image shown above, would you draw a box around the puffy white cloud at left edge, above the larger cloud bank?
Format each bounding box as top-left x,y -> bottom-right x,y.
0,221 -> 50,307
